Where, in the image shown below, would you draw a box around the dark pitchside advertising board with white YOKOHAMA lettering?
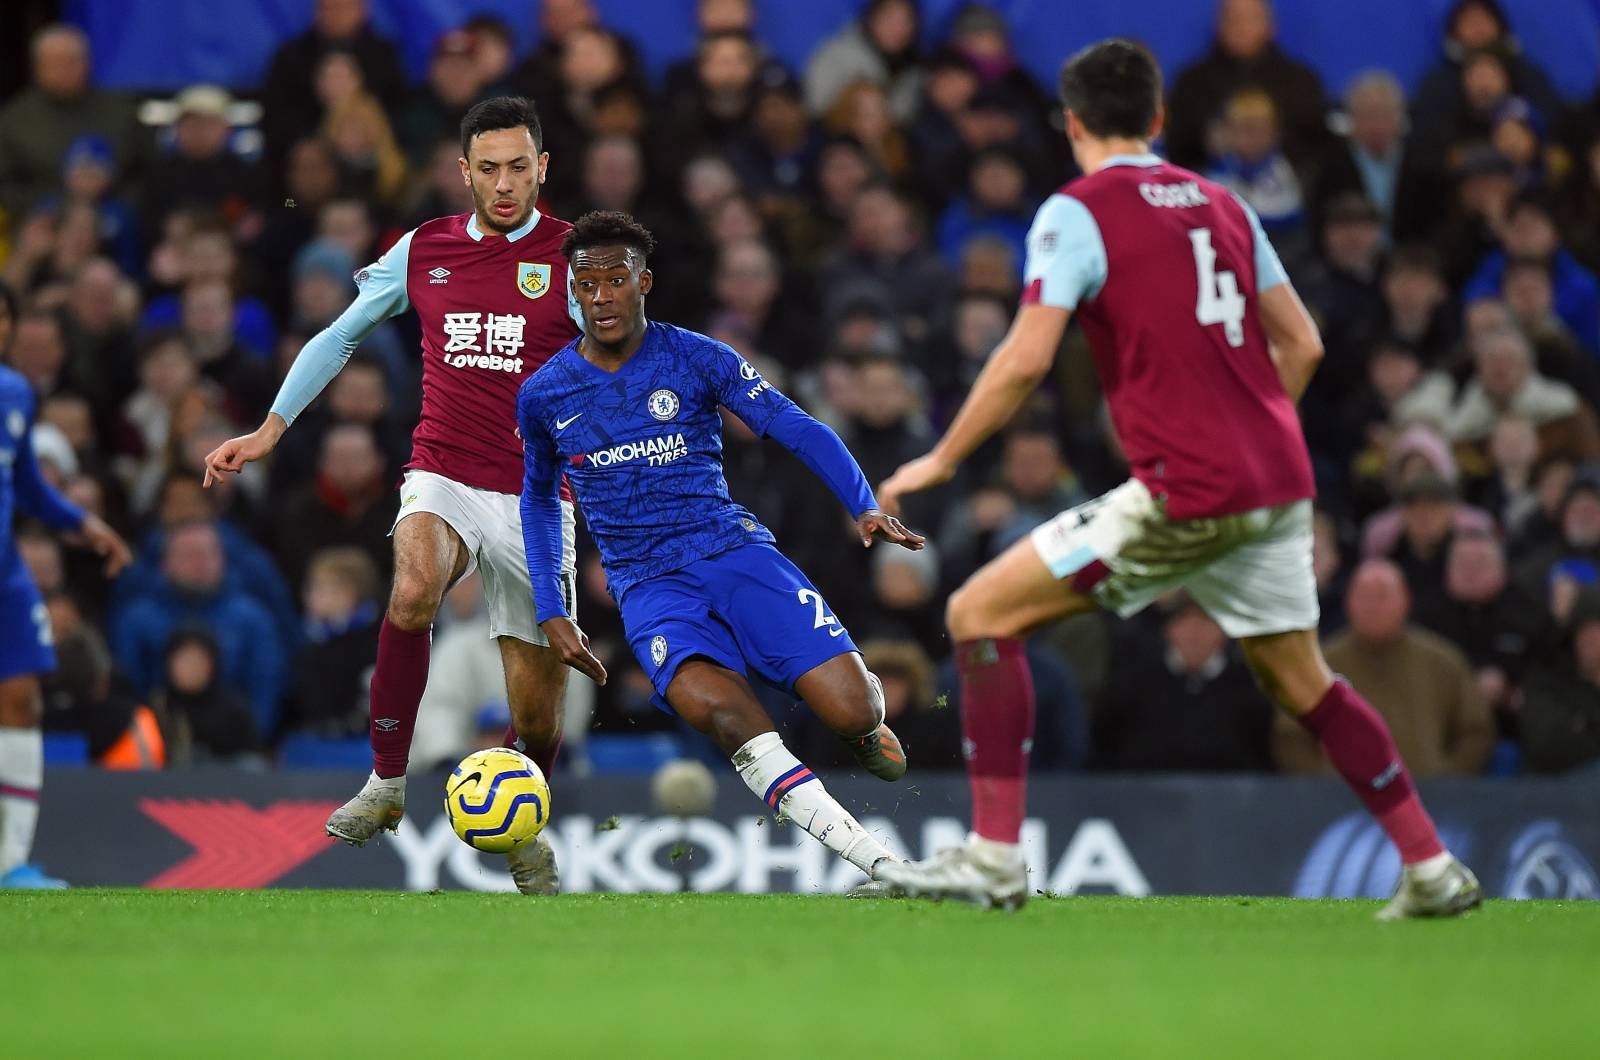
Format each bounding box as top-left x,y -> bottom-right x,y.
35,769 -> 1600,898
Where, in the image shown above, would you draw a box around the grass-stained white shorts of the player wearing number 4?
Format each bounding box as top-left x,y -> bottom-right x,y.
1030,479 -> 1322,639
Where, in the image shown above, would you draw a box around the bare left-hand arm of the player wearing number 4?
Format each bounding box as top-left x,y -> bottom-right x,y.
878,304 -> 1072,512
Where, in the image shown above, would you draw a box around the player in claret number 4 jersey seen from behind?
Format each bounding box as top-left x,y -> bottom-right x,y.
880,40 -> 1482,919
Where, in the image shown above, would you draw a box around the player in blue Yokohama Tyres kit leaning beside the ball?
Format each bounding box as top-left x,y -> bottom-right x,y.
517,211 -> 923,876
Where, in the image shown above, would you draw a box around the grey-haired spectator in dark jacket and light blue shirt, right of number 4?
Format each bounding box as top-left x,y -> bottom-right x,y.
1312,70 -> 1440,243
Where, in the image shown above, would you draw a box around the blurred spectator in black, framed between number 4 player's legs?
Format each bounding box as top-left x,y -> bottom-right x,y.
1091,597 -> 1272,772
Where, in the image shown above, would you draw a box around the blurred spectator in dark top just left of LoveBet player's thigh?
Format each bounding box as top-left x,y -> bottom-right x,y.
283,548 -> 382,738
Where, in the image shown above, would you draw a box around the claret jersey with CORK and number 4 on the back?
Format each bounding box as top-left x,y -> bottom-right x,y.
1022,155 -> 1315,519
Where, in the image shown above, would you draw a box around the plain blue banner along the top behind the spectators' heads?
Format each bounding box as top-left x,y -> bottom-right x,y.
67,0 -> 1600,99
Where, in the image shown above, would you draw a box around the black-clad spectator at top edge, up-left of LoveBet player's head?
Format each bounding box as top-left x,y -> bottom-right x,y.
261,0 -> 406,159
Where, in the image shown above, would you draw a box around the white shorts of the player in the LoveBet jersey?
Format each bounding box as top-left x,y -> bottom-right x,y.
390,471 -> 578,647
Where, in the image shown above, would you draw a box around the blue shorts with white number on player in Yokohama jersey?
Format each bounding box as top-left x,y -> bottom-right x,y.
621,544 -> 858,713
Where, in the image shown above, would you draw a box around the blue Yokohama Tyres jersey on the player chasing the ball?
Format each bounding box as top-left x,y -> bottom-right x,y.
517,322 -> 794,620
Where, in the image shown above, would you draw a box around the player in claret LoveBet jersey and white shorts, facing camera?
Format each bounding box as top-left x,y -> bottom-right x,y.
206,96 -> 578,893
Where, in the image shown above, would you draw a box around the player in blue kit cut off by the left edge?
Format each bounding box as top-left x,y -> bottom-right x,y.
0,283 -> 131,890
